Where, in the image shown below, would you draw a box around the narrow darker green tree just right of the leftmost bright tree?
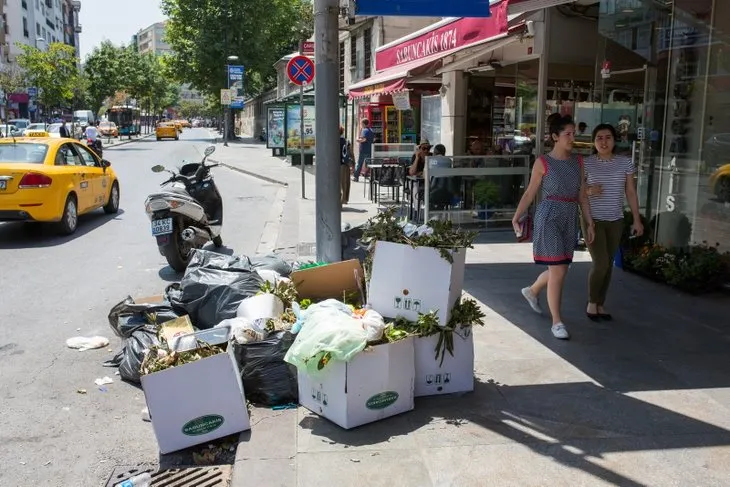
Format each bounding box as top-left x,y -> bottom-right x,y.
84,41 -> 124,113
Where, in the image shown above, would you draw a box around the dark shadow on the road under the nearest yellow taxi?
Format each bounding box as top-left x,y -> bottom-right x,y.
0,208 -> 124,249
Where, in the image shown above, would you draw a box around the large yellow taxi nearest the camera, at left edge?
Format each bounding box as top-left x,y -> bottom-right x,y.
0,130 -> 119,235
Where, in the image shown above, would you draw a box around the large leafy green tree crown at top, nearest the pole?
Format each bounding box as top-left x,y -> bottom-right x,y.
162,0 -> 314,94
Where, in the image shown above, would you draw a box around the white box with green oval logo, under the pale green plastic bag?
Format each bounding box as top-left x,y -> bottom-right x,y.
298,338 -> 415,429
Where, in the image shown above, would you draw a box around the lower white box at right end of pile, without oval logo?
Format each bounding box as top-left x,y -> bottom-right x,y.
414,327 -> 474,397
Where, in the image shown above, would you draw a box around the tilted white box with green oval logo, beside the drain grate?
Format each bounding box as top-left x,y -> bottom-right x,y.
142,347 -> 251,453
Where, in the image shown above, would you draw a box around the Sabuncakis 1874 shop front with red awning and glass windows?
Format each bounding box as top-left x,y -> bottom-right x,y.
347,0 -> 730,255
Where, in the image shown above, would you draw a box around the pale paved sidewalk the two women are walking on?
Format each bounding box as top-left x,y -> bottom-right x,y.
206,135 -> 730,487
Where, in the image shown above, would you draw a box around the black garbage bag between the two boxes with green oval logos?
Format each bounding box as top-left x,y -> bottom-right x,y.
233,331 -> 299,406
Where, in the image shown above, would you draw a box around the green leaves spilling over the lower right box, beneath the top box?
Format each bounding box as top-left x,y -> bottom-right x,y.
384,298 -> 486,366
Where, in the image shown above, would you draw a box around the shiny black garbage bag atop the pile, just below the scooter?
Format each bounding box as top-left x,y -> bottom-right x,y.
165,250 -> 264,330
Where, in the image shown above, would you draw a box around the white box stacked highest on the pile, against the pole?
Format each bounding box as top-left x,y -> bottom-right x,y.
368,242 -> 466,325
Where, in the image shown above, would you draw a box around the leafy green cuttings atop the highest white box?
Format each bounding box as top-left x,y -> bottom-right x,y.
362,207 -> 477,272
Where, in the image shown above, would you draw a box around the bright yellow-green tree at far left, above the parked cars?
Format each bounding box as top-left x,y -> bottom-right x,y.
16,42 -> 79,116
